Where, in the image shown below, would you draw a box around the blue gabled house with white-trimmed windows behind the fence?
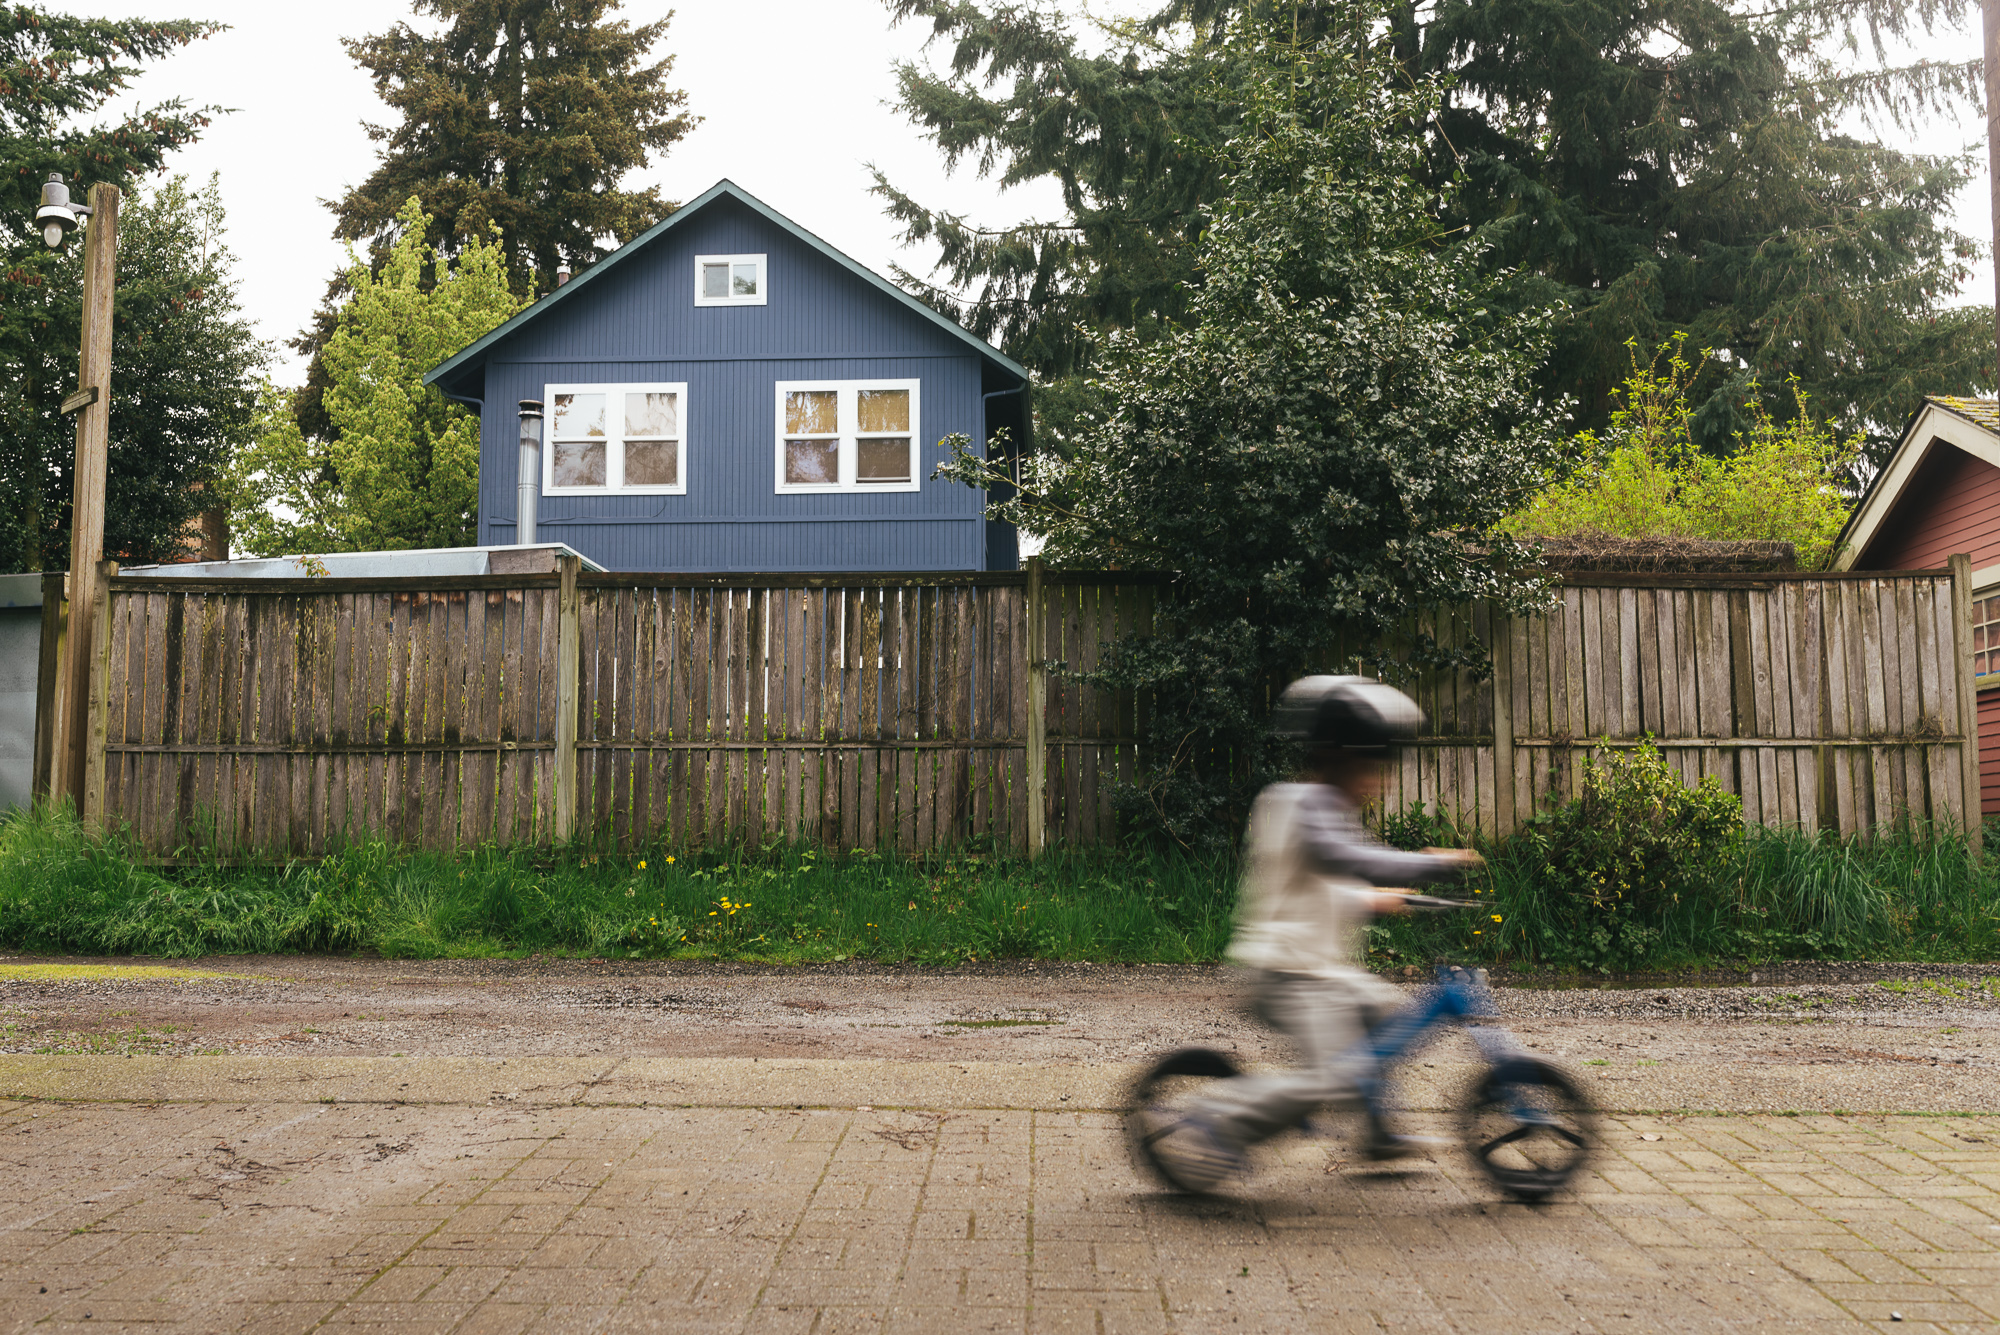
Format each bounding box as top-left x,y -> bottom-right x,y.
428,182 -> 1028,574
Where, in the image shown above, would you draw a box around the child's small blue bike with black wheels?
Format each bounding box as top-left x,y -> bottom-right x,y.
1126,923 -> 1598,1203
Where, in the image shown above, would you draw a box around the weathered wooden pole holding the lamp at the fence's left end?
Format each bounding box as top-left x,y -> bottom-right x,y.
48,186 -> 118,817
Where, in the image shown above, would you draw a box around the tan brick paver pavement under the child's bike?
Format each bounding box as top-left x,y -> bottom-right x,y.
0,1065 -> 2000,1335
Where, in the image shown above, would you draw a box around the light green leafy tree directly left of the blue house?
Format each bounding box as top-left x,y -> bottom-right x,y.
228,196 -> 524,556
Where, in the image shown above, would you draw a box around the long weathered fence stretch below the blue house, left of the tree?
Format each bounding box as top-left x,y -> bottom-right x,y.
58,570 -> 1158,855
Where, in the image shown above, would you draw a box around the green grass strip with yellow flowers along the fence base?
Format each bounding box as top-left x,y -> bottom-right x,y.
0,809 -> 2000,977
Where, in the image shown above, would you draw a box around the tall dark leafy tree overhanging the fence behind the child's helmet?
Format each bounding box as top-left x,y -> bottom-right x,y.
944,18 -> 1564,843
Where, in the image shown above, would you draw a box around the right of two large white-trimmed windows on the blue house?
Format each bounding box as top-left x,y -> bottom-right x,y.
778,380 -> 922,492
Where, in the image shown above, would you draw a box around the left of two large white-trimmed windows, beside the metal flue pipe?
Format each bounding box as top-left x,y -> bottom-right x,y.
542,384 -> 688,496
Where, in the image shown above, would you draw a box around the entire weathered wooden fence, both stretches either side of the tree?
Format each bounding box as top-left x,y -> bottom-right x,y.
38,566 -> 1978,855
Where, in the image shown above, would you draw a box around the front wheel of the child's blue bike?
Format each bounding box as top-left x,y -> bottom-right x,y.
1460,1057 -> 1598,1201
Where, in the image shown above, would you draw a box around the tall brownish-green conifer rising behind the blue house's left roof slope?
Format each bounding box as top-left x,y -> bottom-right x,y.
332,0 -> 696,296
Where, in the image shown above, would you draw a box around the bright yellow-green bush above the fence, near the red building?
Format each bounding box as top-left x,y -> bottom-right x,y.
1502,336 -> 1860,570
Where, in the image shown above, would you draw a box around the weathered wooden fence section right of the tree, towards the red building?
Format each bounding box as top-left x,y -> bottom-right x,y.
1386,558 -> 1980,837
